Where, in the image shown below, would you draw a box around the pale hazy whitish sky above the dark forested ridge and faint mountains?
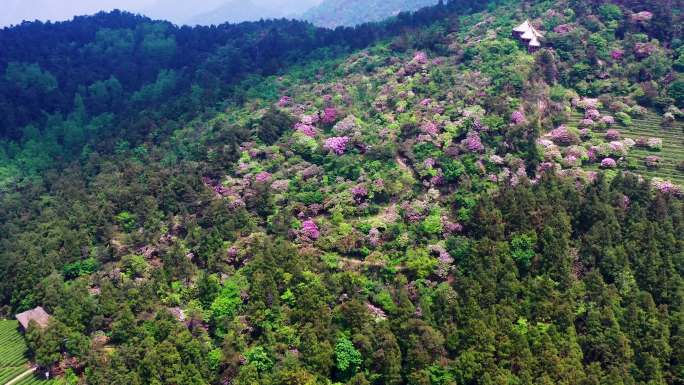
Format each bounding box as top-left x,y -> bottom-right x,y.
0,0 -> 320,27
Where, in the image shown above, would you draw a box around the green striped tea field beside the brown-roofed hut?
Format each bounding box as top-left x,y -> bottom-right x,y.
0,320 -> 53,385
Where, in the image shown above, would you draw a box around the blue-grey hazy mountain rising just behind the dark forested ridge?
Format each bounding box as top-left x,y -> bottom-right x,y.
302,0 -> 438,28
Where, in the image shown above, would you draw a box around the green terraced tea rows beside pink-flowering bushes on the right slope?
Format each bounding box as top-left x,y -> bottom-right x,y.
568,113 -> 684,186
